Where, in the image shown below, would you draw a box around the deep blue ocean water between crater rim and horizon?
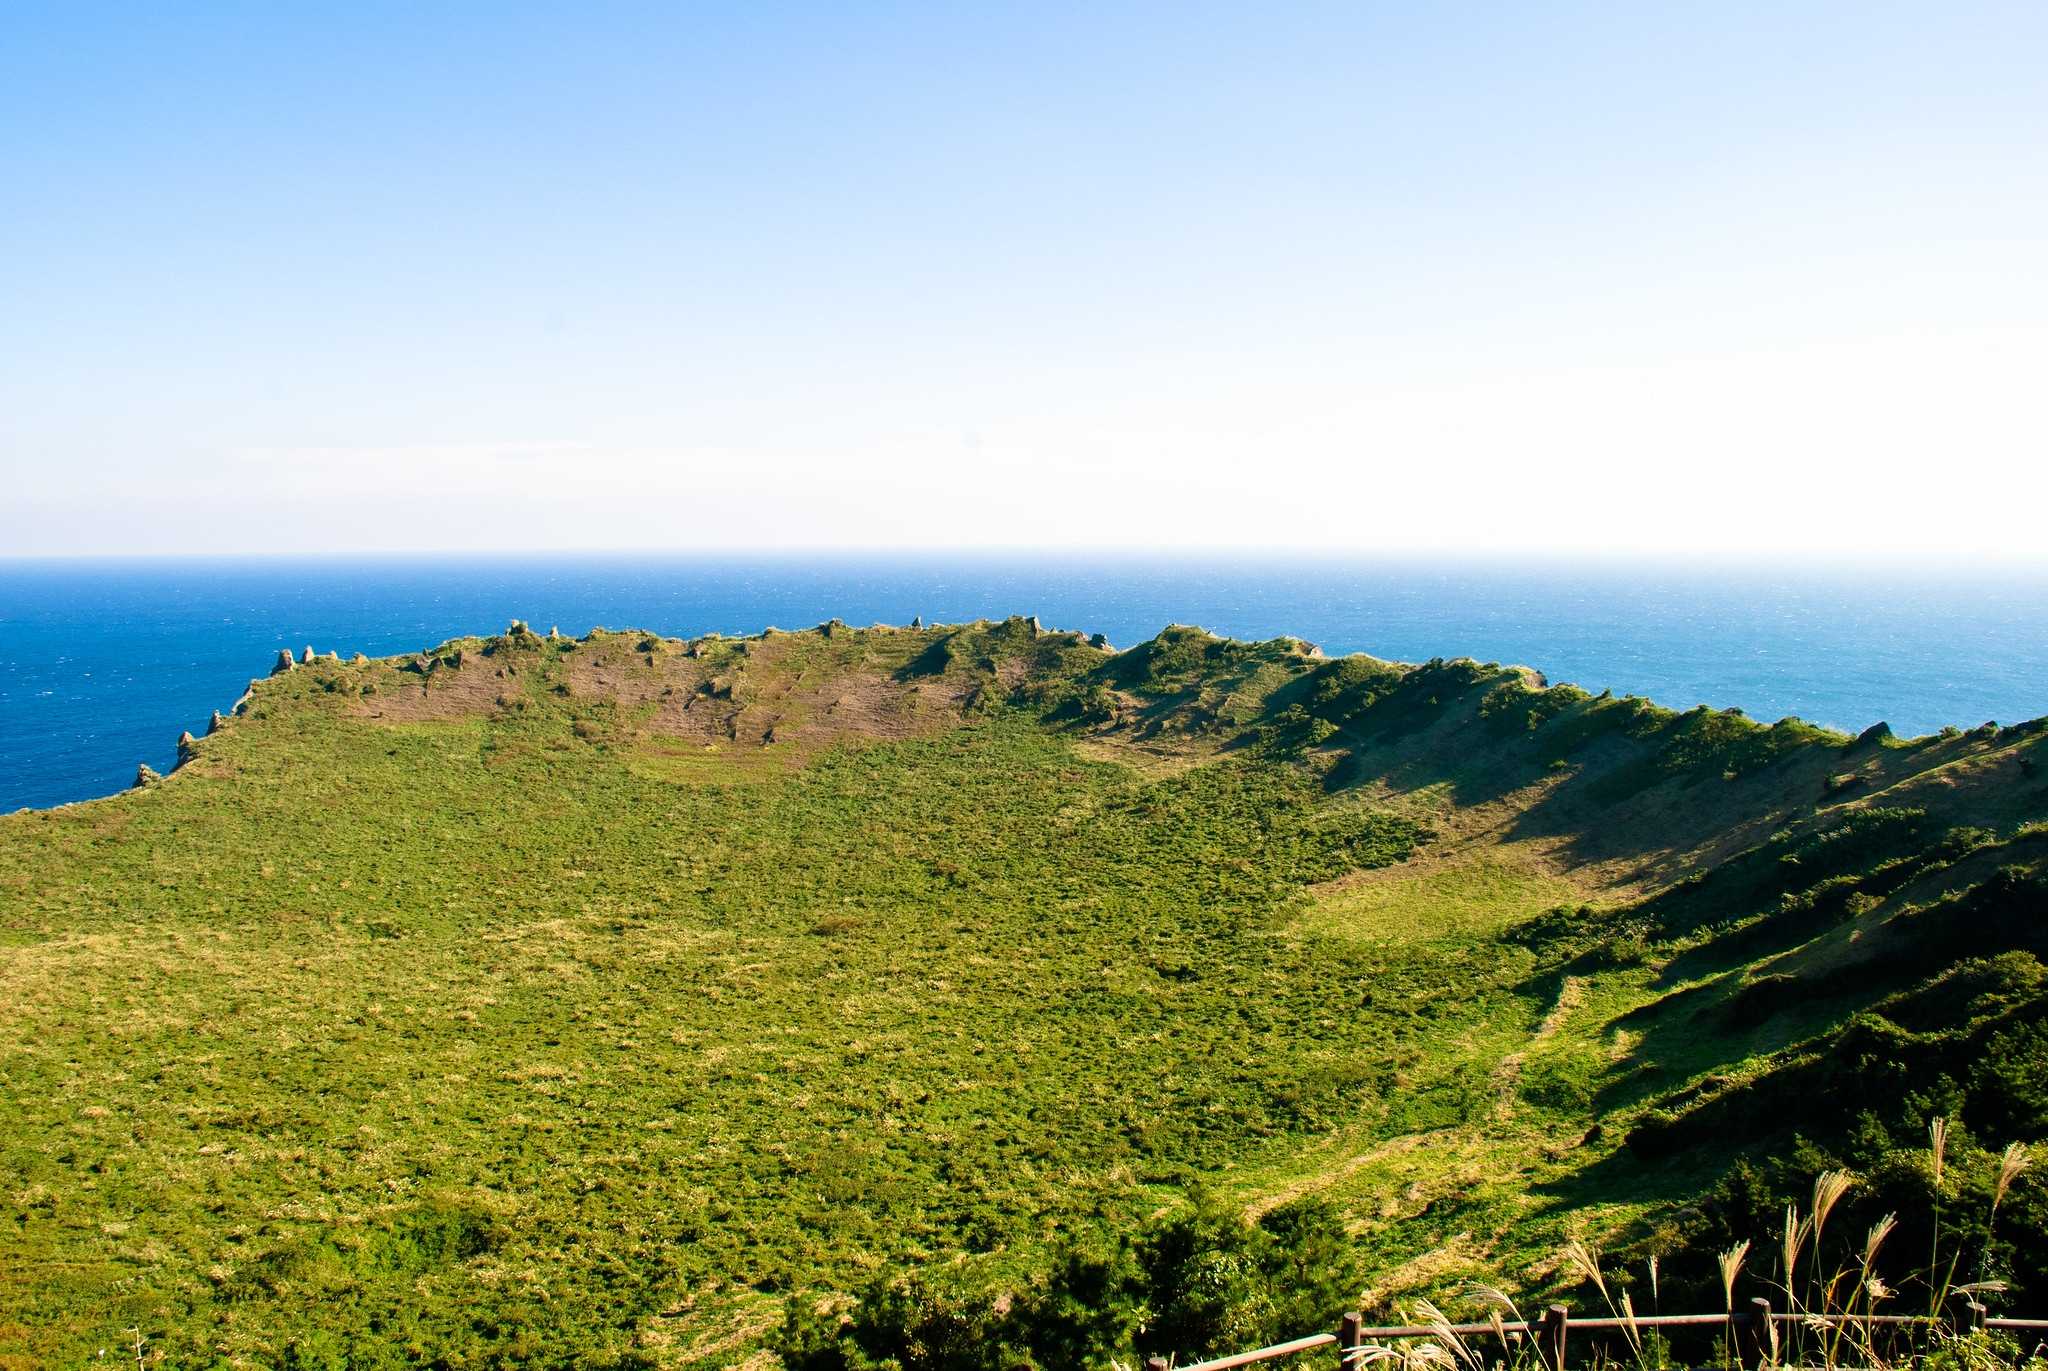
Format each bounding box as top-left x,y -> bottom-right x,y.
0,555 -> 2048,812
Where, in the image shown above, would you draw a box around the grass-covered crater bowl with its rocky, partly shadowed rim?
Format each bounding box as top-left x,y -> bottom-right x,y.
0,619 -> 2048,1367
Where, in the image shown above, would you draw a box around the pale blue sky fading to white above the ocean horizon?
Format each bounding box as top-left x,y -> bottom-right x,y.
0,0 -> 2048,559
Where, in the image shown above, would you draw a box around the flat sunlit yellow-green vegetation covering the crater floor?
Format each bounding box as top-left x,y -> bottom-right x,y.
0,655 -> 1477,1361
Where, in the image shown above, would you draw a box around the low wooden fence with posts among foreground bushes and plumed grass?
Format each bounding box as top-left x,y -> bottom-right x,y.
1145,1299 -> 2048,1371
